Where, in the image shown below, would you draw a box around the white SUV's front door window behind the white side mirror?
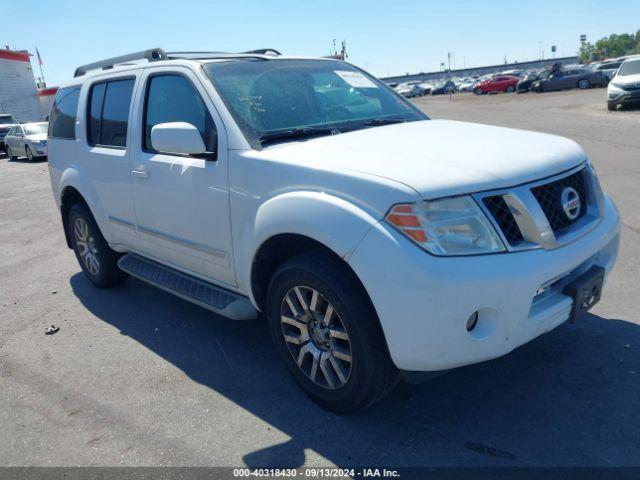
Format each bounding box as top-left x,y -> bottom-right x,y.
143,74 -> 218,153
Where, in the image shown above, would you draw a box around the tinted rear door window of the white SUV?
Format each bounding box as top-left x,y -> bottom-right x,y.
87,78 -> 135,147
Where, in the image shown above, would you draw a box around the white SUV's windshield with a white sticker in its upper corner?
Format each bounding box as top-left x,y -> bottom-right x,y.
204,60 -> 428,147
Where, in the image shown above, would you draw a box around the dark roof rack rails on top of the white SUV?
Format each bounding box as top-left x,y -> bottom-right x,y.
73,48 -> 282,77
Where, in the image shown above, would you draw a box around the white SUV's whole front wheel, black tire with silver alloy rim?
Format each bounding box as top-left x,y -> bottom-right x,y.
266,253 -> 399,413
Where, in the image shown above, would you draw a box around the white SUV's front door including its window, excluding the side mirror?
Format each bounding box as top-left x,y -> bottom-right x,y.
126,67 -> 235,285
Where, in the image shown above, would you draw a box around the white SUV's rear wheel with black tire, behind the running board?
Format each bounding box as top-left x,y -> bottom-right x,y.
67,203 -> 127,287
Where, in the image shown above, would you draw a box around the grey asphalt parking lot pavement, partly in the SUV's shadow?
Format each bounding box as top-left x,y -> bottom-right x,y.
0,89 -> 640,466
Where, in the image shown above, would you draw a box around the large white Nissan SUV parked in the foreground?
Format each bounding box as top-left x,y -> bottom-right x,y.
49,49 -> 619,412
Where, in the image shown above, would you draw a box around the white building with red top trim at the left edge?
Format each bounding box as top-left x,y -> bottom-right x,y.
0,49 -> 44,122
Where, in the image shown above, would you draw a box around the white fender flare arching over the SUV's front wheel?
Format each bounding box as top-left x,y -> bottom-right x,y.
235,191 -> 379,305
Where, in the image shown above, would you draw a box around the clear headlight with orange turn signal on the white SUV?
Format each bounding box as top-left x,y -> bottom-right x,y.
386,196 -> 505,255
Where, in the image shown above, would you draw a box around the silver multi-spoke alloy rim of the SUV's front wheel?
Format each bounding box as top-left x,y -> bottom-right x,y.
280,286 -> 353,390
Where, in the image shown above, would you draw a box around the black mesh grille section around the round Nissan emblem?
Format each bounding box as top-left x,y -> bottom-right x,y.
531,169 -> 587,234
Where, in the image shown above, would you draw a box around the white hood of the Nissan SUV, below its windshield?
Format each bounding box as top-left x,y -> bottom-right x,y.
262,120 -> 586,199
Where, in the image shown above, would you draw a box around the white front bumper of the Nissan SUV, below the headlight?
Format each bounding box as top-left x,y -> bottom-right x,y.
349,198 -> 620,371
